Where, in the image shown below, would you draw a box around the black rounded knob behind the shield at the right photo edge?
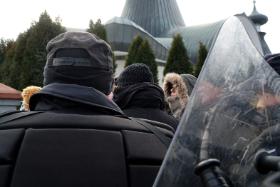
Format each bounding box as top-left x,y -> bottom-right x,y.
255,150 -> 280,174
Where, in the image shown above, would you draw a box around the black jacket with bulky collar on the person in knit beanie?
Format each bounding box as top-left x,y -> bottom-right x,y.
114,82 -> 178,129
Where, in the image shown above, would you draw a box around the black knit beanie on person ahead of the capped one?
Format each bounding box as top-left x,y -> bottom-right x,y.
116,63 -> 154,87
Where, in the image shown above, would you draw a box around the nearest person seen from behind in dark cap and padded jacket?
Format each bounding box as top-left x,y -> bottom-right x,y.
0,32 -> 173,187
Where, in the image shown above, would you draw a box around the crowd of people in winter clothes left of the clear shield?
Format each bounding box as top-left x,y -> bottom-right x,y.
0,32 -> 279,187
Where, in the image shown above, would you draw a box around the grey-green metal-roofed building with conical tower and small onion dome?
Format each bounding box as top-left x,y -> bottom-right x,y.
105,0 -> 270,79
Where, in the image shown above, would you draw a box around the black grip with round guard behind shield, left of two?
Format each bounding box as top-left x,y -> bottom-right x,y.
195,159 -> 230,187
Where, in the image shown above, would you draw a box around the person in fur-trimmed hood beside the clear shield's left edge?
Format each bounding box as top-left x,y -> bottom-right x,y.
163,73 -> 196,119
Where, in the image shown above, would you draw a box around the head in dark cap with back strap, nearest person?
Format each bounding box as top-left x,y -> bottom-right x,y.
44,32 -> 113,95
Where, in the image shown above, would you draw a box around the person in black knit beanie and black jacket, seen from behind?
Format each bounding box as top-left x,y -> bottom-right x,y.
113,63 -> 178,129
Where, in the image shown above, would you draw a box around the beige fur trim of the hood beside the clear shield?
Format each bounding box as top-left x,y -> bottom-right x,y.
163,73 -> 188,118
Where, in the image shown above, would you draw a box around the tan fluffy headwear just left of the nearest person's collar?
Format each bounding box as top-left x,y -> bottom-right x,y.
20,86 -> 42,111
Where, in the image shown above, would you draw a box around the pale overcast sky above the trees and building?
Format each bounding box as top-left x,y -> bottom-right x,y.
0,0 -> 280,53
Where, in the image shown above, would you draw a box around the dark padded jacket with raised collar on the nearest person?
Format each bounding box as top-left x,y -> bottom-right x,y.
0,84 -> 173,187
